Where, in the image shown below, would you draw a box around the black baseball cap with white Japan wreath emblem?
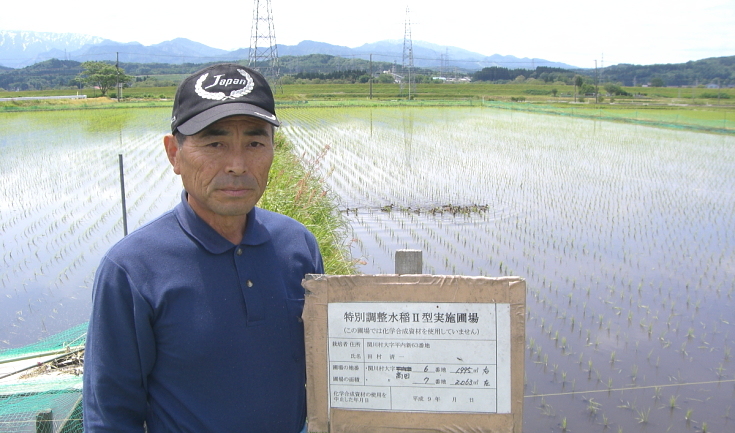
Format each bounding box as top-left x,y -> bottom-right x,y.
171,63 -> 281,135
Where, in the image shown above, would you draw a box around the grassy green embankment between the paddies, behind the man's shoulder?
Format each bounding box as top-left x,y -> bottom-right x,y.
258,133 -> 357,275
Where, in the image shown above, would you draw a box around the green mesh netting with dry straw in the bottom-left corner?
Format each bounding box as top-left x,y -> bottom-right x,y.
0,323 -> 87,433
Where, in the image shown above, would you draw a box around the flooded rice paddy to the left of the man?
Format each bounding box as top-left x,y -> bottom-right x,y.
0,109 -> 181,344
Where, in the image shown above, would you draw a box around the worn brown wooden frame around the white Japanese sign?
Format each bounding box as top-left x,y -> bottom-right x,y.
302,275 -> 526,433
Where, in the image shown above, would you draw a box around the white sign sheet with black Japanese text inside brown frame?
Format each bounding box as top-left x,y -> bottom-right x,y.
327,302 -> 511,413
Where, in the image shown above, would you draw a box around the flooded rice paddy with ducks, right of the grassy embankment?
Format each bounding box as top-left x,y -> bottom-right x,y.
282,108 -> 735,432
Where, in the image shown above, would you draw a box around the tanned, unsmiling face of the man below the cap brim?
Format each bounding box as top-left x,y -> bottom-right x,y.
164,116 -> 273,229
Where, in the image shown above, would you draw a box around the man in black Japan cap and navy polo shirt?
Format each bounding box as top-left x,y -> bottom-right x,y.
84,64 -> 323,433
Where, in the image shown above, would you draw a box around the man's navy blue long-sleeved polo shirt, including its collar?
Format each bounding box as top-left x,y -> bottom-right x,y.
83,192 -> 324,433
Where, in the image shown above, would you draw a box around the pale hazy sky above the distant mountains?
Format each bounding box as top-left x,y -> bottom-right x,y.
0,0 -> 735,68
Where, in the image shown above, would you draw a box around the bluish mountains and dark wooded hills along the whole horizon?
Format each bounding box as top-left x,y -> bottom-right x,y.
0,30 -> 735,90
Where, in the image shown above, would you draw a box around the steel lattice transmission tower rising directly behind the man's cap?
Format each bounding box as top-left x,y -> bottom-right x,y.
248,0 -> 283,93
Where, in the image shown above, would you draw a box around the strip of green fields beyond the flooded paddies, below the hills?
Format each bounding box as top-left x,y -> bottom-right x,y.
0,82 -> 735,134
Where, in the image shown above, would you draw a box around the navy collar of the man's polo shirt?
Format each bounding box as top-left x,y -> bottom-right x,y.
174,191 -> 270,254
